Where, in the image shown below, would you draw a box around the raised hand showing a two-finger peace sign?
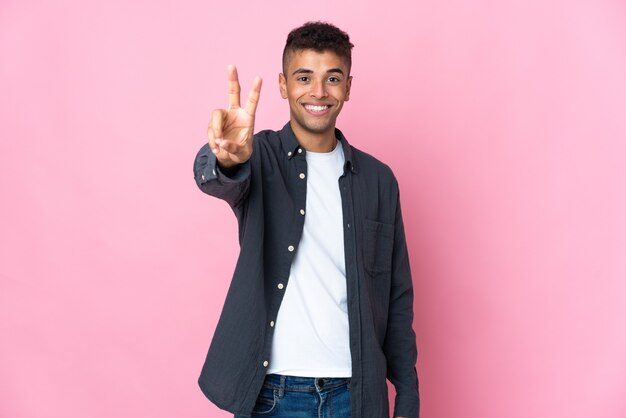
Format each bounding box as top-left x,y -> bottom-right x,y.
207,65 -> 262,168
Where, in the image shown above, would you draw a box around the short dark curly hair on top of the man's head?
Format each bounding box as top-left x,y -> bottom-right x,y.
283,22 -> 354,75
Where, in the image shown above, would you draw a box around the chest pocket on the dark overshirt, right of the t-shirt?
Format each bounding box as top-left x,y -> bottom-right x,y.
363,219 -> 393,276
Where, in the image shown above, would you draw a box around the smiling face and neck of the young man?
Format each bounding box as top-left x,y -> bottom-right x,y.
279,49 -> 352,151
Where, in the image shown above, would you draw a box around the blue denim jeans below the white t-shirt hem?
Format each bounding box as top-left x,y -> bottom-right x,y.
235,374 -> 351,418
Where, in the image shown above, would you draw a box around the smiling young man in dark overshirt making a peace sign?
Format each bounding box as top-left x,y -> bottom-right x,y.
194,22 -> 419,418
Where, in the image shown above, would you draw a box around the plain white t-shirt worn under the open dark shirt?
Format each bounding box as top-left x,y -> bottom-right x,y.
267,142 -> 352,377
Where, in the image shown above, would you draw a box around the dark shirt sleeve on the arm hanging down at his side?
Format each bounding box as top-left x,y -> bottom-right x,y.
383,192 -> 420,418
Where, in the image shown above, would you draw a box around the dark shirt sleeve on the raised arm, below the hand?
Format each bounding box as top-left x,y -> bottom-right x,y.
193,144 -> 251,209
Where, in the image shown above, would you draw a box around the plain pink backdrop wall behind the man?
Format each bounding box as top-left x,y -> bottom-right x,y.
0,0 -> 626,418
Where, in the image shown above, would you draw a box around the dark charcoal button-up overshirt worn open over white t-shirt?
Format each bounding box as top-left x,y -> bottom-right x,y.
194,123 -> 419,418
